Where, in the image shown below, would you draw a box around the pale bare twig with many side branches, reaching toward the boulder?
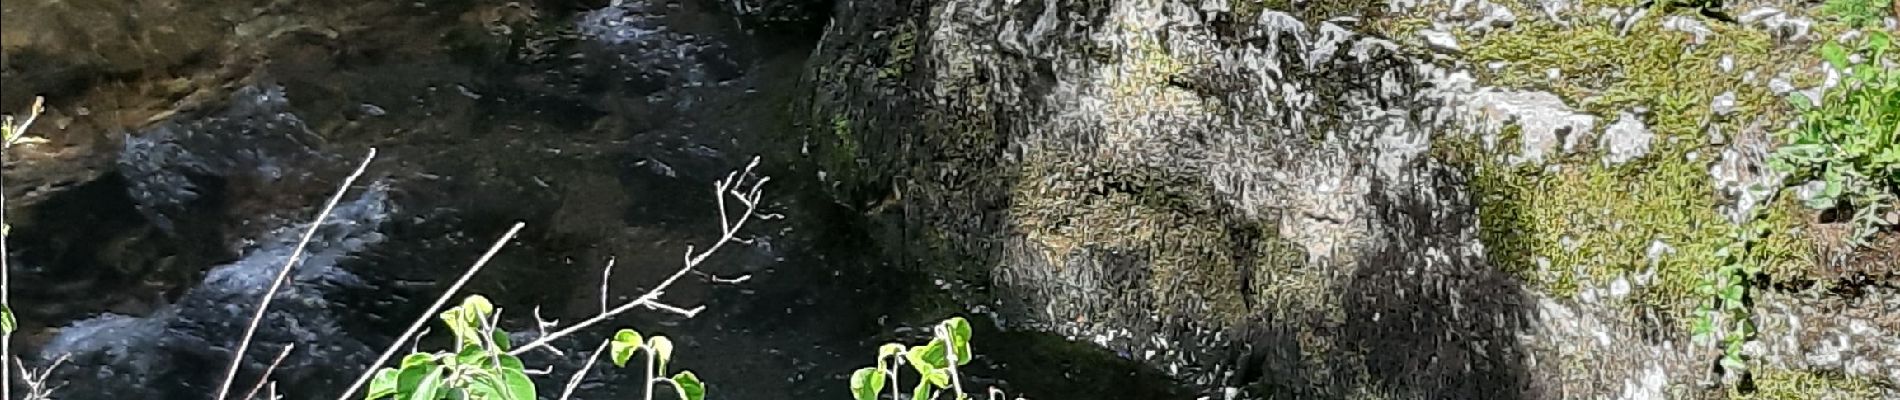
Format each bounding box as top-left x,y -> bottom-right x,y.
507,157 -> 771,356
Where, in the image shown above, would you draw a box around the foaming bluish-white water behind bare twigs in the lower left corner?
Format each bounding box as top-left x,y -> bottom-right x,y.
40,190 -> 390,400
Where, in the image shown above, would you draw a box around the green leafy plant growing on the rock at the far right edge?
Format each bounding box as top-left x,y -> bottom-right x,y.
1769,32 -> 1900,245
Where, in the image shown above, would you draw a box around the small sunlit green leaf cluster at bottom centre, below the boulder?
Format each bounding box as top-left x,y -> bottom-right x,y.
851,317 -> 971,400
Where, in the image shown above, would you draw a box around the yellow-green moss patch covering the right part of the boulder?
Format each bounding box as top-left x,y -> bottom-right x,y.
1440,17 -> 1809,309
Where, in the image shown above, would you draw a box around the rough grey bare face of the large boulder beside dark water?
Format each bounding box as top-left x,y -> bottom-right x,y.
800,0 -> 1879,398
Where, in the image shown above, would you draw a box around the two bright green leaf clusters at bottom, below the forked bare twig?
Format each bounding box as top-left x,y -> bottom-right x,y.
365,296 -> 707,400
